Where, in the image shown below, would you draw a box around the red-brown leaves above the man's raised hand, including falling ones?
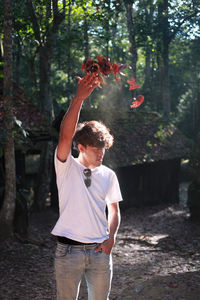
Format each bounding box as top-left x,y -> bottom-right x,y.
80,56 -> 144,108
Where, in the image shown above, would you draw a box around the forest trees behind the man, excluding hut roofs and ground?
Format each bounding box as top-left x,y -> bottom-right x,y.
0,0 -> 200,239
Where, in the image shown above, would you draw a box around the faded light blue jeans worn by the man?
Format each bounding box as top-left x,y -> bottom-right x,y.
55,243 -> 112,300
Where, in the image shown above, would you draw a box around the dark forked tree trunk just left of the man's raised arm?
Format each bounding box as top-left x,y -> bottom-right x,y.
27,0 -> 65,122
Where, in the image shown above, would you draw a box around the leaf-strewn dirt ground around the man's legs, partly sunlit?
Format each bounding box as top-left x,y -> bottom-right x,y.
0,183 -> 200,300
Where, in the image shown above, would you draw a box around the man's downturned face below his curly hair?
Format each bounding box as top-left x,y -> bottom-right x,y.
79,145 -> 105,168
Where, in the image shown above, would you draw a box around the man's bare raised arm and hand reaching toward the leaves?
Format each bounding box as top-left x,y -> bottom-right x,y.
57,75 -> 98,162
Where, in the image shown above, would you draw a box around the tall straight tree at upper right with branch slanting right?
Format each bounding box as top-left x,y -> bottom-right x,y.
155,0 -> 199,121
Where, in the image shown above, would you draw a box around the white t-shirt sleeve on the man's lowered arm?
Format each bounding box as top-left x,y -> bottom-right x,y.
106,173 -> 123,203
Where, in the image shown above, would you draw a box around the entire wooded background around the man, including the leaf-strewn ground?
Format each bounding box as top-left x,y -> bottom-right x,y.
0,0 -> 200,300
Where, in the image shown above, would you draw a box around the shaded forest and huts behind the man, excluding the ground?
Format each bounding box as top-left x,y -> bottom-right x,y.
0,0 -> 200,235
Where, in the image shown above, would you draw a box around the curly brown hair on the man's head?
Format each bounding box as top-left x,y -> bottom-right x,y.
73,121 -> 114,149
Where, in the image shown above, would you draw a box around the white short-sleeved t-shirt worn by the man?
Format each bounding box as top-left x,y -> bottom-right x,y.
52,152 -> 122,243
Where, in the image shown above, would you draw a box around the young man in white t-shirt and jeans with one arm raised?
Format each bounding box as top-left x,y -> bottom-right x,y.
52,75 -> 122,300
